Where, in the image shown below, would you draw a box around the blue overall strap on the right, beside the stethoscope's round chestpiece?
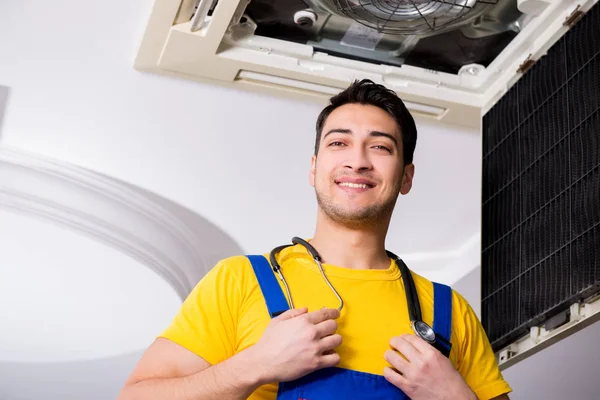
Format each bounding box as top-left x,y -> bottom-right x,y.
433,282 -> 452,357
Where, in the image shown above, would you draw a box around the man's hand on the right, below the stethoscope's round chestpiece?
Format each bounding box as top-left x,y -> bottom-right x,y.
383,335 -> 477,400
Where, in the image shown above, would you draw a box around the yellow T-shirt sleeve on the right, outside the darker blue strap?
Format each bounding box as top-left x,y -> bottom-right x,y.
454,292 -> 512,400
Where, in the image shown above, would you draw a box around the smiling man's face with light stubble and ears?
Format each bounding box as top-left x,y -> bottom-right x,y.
310,104 -> 414,226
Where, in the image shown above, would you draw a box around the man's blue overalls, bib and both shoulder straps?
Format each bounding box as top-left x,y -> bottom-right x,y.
247,255 -> 452,400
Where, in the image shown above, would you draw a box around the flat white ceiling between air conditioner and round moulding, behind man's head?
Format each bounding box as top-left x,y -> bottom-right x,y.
0,0 -> 481,275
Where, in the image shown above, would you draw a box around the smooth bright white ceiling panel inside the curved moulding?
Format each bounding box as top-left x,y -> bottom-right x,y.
0,209 -> 181,363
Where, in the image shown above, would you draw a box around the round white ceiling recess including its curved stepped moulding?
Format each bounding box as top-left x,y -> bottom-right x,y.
0,141 -> 246,363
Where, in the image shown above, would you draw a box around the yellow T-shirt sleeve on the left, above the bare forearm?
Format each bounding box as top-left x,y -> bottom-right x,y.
159,261 -> 242,365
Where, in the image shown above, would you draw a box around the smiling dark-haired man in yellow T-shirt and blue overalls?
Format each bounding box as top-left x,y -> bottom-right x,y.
120,80 -> 511,400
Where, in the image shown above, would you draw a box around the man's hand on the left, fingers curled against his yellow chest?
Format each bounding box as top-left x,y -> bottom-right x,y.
248,308 -> 342,383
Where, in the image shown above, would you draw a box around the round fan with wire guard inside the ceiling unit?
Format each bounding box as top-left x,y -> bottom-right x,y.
334,0 -> 498,35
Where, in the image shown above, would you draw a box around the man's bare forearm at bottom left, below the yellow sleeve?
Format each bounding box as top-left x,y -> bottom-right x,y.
119,351 -> 263,400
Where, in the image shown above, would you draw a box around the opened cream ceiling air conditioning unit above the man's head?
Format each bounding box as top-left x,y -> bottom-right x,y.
135,0 -> 595,128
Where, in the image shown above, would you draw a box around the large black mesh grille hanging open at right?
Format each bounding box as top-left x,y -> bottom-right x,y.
482,5 -> 600,351
